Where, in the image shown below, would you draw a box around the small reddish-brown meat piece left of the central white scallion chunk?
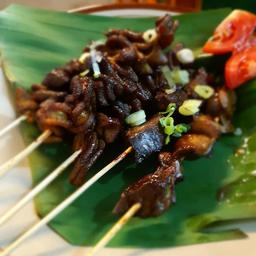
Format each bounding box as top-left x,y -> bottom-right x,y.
96,113 -> 121,144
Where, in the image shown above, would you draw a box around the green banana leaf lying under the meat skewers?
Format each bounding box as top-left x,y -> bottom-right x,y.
0,5 -> 256,248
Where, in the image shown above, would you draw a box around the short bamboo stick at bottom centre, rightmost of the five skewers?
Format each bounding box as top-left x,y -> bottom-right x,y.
86,203 -> 141,256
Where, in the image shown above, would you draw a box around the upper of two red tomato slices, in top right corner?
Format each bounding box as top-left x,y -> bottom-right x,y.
203,10 -> 256,54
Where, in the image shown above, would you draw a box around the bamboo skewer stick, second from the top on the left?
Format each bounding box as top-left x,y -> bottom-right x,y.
0,130 -> 51,177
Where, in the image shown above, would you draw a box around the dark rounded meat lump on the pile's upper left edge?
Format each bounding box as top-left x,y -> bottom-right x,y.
42,68 -> 70,90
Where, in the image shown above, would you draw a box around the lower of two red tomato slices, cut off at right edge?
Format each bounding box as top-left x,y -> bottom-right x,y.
225,46 -> 256,89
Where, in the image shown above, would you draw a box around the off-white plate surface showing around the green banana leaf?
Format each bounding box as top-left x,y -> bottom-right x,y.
0,10 -> 256,256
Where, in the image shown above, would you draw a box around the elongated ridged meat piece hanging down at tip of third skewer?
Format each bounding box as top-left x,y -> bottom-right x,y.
69,132 -> 105,186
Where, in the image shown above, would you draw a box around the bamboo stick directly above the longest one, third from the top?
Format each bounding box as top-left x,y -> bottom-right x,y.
0,150 -> 81,226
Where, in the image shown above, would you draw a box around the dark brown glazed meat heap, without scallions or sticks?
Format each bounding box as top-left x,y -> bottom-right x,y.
16,15 -> 235,217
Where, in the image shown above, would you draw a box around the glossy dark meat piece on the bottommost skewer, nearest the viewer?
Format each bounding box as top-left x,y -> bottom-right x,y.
114,161 -> 179,218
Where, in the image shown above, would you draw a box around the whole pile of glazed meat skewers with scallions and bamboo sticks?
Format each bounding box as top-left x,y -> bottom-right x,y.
0,15 -> 235,255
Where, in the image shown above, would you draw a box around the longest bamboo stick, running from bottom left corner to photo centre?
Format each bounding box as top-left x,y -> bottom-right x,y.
0,147 -> 132,256
